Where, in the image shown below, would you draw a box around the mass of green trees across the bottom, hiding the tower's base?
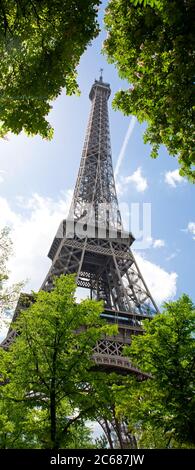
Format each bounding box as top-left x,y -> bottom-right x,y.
0,275 -> 195,449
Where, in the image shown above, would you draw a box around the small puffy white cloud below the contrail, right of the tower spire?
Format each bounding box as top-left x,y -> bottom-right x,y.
116,167 -> 148,194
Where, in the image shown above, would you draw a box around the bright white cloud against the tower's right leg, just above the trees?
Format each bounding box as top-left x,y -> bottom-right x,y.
134,253 -> 178,305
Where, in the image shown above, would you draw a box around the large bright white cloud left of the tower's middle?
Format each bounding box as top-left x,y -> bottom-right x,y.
0,191 -> 72,291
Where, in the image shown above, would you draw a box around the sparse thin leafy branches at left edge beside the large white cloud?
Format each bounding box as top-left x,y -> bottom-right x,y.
0,227 -> 22,327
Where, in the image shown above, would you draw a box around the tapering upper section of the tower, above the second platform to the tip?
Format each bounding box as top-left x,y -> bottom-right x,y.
69,74 -> 122,229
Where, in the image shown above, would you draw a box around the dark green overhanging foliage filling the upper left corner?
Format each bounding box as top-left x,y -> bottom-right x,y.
0,0 -> 100,138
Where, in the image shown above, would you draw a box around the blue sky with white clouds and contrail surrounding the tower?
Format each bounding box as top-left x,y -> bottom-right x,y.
0,4 -> 195,342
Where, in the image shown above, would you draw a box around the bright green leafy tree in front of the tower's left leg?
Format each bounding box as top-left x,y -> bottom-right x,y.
0,275 -> 116,448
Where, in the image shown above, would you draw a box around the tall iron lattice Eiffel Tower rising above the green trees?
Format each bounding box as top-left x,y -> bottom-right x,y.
41,76 -> 157,374
